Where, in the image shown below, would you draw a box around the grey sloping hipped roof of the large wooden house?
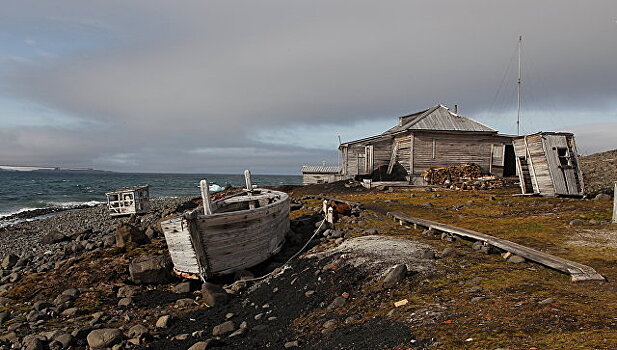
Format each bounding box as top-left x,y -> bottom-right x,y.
382,105 -> 497,135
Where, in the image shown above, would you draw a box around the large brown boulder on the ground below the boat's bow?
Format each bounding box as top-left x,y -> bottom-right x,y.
129,255 -> 172,284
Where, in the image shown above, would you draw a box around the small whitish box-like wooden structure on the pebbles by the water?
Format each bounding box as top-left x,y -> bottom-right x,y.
105,185 -> 150,216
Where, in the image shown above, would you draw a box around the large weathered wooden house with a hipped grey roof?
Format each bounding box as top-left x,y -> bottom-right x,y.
339,105 -> 516,184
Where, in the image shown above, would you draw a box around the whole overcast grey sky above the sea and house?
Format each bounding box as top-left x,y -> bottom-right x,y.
0,0 -> 617,174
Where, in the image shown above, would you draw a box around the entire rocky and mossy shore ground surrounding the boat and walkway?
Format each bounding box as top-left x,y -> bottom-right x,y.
0,162 -> 617,350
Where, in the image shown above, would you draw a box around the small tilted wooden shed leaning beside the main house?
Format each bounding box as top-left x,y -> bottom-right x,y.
513,132 -> 585,196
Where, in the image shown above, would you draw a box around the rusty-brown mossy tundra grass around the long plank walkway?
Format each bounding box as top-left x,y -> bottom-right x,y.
306,190 -> 617,349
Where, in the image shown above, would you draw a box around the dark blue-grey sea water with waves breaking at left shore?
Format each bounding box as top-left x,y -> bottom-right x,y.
0,171 -> 302,226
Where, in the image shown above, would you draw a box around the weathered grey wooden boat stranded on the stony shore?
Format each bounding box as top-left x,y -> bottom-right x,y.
161,170 -> 289,280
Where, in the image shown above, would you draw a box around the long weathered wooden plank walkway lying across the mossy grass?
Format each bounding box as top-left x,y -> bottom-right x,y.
388,212 -> 605,282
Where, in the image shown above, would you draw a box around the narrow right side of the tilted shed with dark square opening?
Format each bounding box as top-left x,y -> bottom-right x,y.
544,135 -> 581,195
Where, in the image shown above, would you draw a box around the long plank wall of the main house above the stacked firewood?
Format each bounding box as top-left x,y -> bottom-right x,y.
410,132 -> 511,176
